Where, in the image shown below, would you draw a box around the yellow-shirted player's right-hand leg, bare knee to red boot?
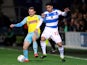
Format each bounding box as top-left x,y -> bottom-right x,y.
32,34 -> 39,57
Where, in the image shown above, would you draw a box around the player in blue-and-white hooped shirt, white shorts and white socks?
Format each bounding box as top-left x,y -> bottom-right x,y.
41,3 -> 70,62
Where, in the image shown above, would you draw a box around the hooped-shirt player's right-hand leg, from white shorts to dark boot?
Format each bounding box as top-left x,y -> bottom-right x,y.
52,32 -> 65,61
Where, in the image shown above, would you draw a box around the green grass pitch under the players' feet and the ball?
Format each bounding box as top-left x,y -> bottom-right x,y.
0,48 -> 87,65
